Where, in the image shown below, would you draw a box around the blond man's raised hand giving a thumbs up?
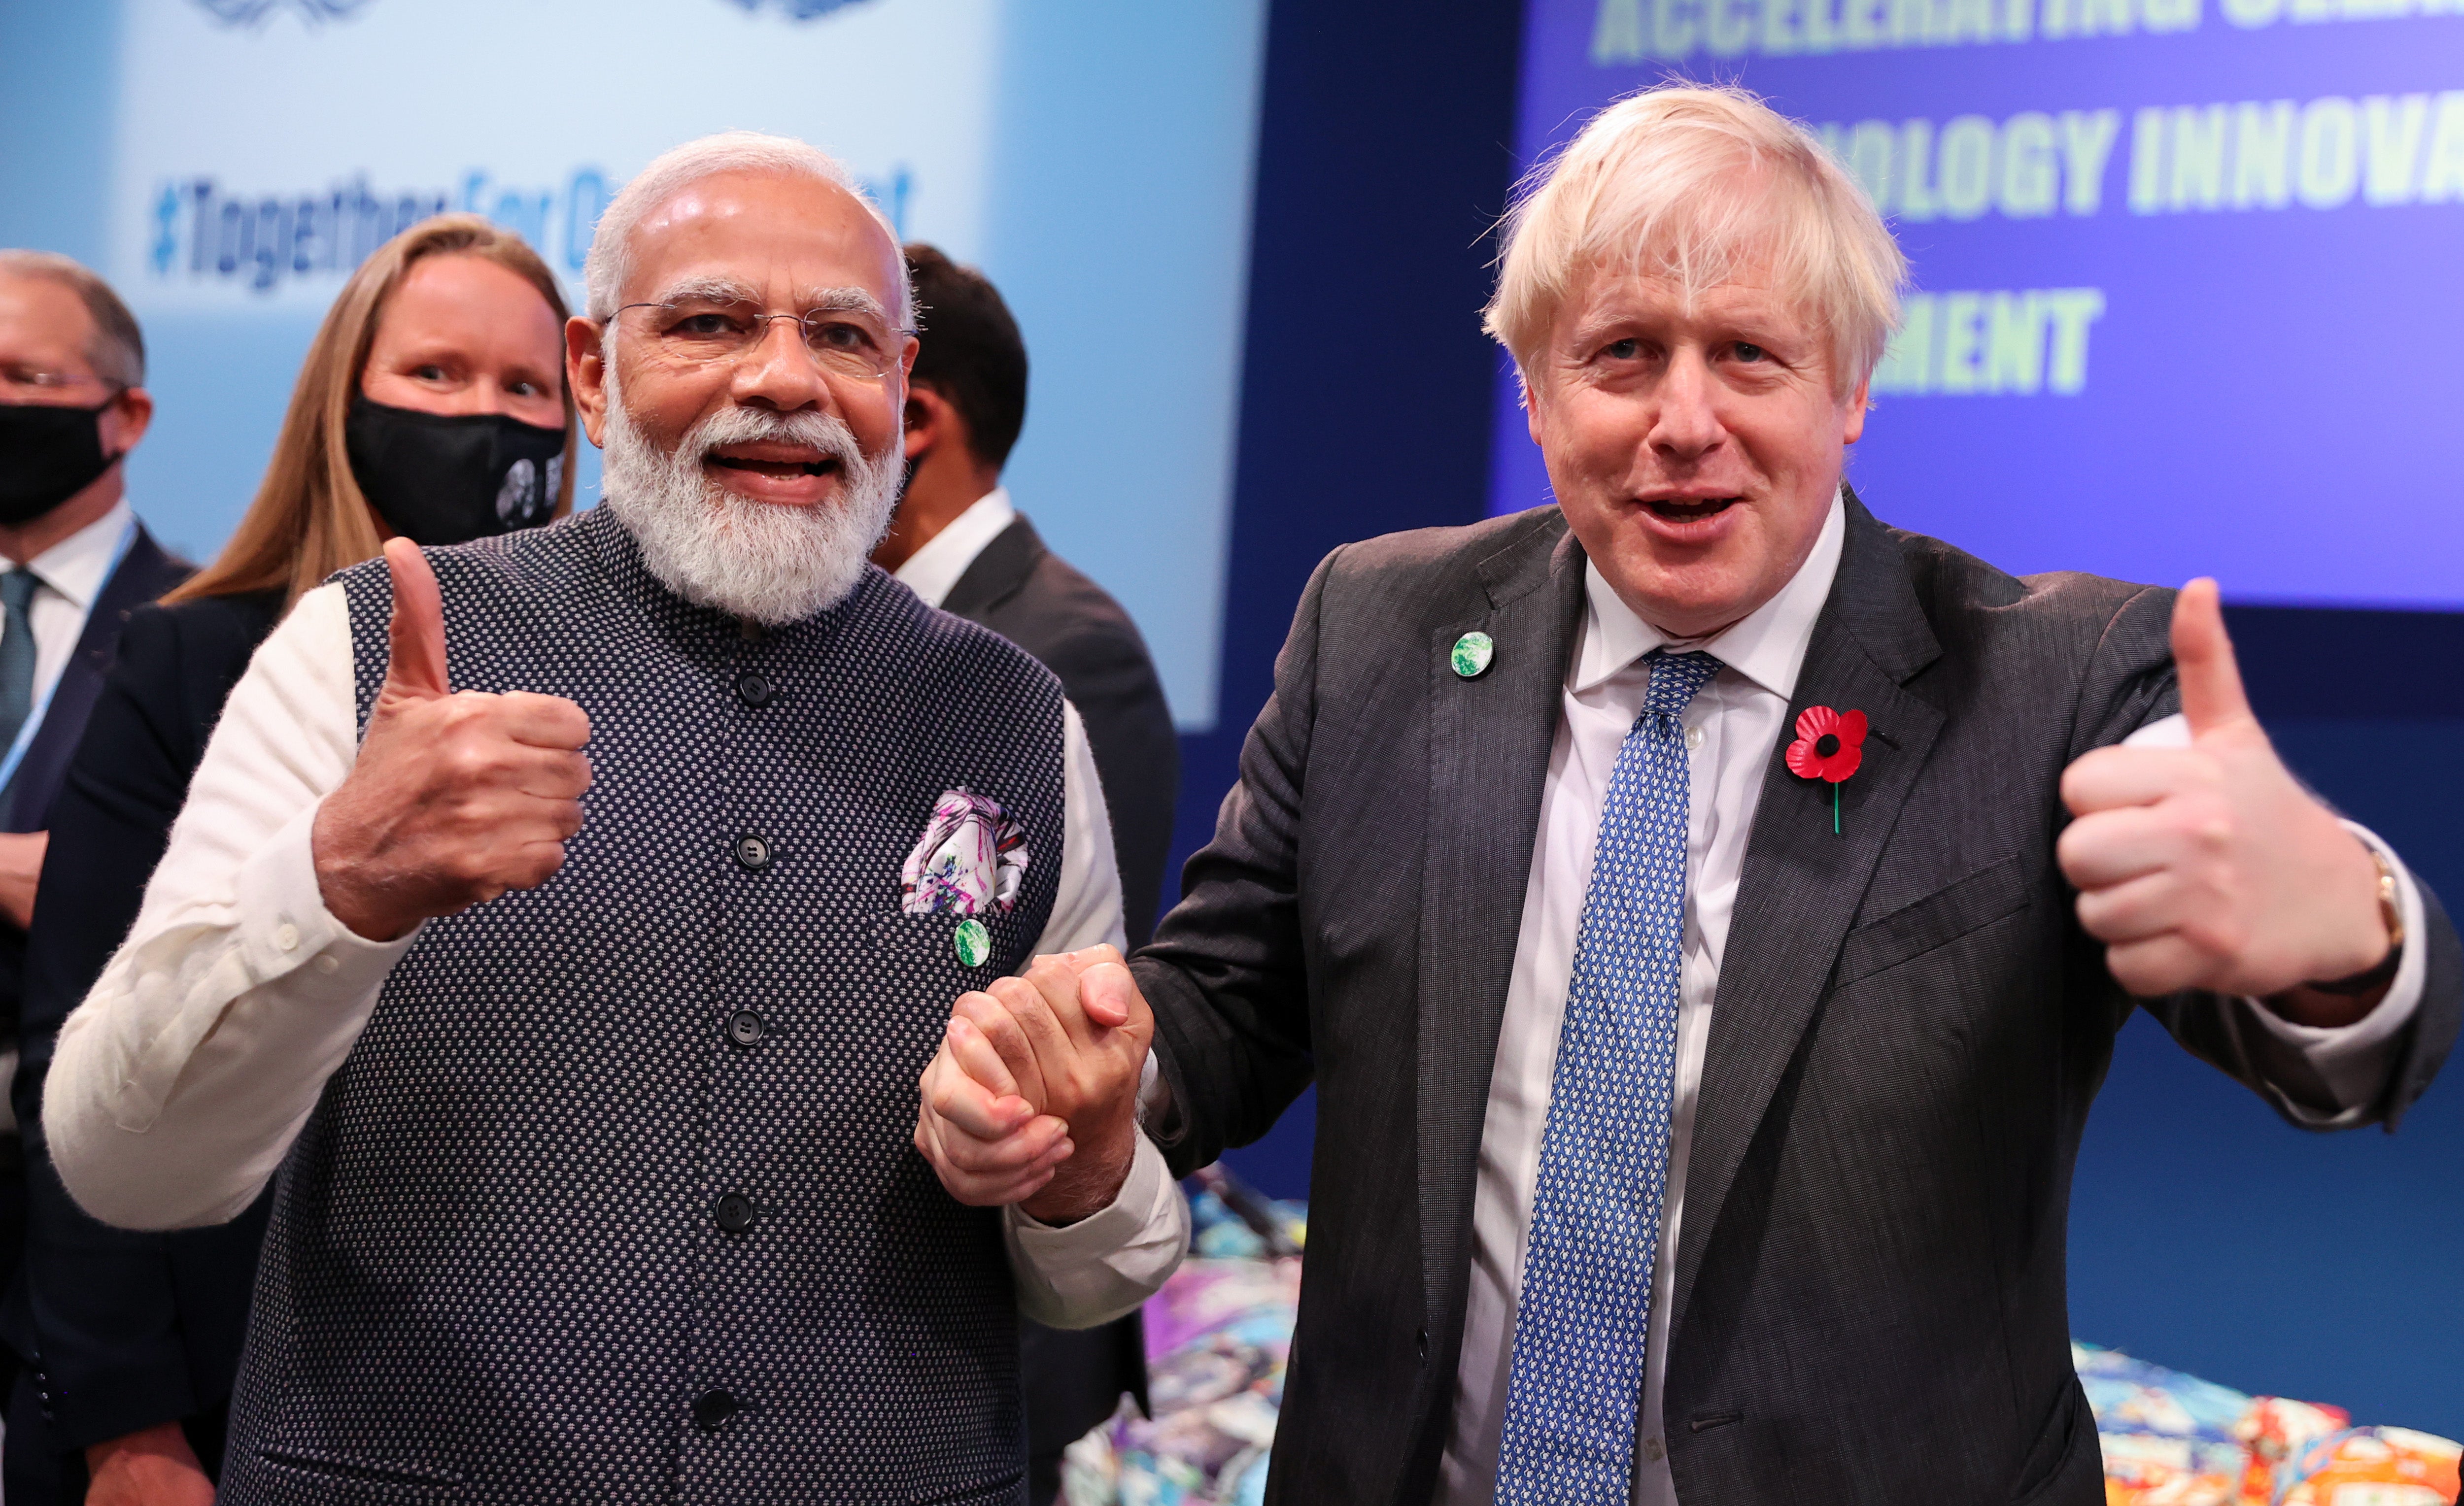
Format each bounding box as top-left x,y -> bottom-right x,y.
2055,579 -> 2390,1025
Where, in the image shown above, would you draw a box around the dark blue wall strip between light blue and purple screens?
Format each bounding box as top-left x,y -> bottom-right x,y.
1165,0 -> 1523,1196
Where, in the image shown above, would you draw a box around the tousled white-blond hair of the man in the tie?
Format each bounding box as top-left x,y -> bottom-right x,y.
1483,84 -> 1907,397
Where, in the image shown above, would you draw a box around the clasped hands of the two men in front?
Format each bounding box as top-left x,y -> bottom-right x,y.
917,946 -> 1156,1225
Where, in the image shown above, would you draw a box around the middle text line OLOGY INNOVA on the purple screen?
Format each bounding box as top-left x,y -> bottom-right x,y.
1816,89 -> 2464,222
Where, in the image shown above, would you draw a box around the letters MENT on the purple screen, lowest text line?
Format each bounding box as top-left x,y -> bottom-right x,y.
1873,288 -> 2104,397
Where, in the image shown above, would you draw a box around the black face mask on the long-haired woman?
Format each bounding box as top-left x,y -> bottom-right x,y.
342,395 -> 564,545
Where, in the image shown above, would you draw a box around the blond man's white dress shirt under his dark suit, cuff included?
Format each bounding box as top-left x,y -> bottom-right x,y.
1437,503 -> 2425,1506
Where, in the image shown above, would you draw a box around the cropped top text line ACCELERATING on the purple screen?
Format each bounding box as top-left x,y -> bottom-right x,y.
1592,0 -> 2464,67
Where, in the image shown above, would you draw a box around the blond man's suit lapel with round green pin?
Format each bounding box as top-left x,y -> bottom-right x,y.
1419,508 -> 1582,1339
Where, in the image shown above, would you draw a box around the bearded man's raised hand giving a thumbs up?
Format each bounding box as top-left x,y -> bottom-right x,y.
310,537 -> 591,941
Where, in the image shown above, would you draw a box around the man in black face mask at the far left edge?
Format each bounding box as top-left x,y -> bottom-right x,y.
0,249 -> 190,1368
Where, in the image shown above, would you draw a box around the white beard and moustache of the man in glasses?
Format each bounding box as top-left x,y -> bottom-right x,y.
601,374 -> 904,626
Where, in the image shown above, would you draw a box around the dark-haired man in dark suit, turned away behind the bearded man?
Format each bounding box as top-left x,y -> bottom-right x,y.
872,244 -> 1180,1506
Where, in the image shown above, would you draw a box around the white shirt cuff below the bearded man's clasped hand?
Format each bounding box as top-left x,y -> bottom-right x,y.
1003,1134 -> 1190,1329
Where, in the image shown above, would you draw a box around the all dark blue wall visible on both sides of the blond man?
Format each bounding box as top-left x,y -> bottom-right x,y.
1198,0 -> 2464,1437
